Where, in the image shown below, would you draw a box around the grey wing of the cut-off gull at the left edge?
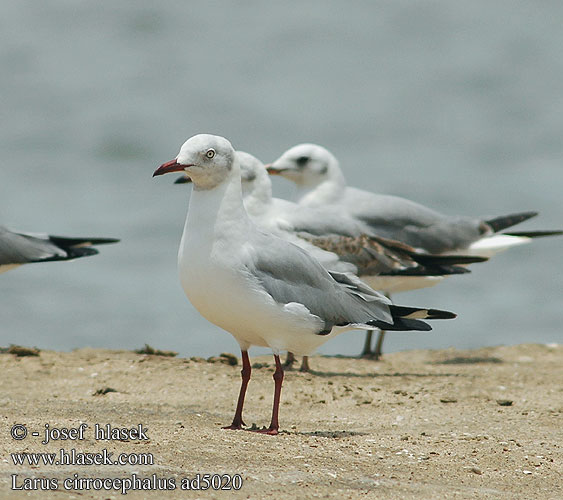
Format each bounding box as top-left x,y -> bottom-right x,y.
0,226 -> 66,265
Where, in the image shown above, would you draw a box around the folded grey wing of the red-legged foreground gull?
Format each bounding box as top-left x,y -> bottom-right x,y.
250,232 -> 393,331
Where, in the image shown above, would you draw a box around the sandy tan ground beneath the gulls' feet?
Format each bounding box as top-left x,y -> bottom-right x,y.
0,345 -> 563,499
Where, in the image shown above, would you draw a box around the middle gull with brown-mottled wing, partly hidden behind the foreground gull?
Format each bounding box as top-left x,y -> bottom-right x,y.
176,151 -> 486,372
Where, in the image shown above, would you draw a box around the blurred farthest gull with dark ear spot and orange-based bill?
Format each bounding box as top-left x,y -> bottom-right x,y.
268,144 -> 562,359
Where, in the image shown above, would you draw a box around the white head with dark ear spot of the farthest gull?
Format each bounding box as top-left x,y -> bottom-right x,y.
267,144 -> 342,187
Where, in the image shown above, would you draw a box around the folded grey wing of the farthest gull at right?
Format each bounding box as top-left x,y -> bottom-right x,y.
343,188 -> 490,253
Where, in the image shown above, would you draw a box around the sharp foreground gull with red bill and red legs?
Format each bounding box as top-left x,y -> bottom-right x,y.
153,134 -> 455,435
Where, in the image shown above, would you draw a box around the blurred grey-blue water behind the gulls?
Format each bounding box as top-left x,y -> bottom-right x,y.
0,0 -> 563,356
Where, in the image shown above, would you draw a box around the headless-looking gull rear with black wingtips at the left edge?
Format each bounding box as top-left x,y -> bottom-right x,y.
0,226 -> 119,273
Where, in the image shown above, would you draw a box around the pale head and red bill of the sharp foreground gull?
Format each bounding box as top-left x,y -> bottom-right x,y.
153,134 -> 235,189
